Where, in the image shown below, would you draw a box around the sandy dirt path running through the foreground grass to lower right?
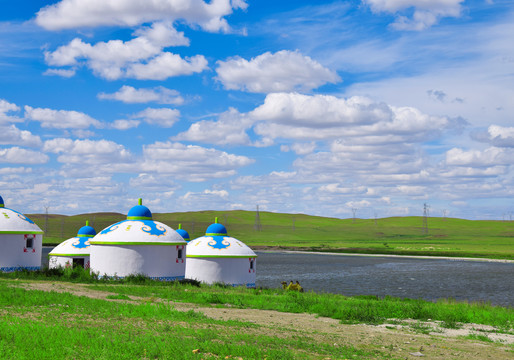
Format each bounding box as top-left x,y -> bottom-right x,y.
11,282 -> 514,360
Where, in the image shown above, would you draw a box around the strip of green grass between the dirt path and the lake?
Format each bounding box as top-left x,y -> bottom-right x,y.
0,268 -> 514,332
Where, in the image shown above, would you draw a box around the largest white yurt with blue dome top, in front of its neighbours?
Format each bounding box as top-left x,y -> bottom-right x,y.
90,199 -> 187,280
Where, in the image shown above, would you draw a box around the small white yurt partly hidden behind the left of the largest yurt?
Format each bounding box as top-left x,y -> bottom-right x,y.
48,221 -> 96,269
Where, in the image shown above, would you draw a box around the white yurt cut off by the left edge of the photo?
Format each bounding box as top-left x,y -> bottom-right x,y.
0,196 -> 43,272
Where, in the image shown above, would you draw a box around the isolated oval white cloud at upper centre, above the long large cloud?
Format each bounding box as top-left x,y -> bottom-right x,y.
216,50 -> 341,93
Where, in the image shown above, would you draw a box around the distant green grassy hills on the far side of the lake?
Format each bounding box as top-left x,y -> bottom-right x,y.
29,210 -> 514,260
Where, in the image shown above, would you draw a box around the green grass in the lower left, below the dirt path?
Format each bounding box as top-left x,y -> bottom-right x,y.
0,279 -> 387,359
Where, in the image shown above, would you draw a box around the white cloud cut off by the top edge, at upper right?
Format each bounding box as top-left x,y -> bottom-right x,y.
364,0 -> 464,30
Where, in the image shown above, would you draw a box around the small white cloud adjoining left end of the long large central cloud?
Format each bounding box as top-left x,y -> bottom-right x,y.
172,108 -> 253,145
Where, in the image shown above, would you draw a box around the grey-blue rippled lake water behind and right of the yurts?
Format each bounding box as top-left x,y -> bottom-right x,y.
43,247 -> 514,307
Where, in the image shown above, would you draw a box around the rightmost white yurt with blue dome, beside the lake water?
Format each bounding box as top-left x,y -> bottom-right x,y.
186,218 -> 257,288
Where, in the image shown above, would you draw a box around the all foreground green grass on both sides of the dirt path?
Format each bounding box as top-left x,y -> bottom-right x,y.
0,268 -> 514,359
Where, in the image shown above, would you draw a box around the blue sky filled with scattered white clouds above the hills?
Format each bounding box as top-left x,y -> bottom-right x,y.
0,0 -> 514,219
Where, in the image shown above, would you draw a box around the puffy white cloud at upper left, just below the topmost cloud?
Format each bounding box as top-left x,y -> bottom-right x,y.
45,23 -> 207,80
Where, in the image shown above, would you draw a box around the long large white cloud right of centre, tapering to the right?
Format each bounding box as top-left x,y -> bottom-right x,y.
249,93 -> 452,144
